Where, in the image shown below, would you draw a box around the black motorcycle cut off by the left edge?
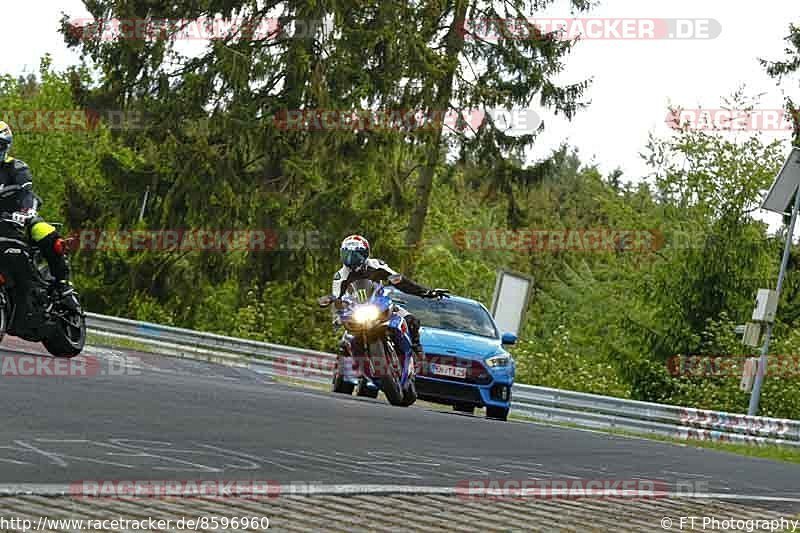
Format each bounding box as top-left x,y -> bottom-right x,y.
0,213 -> 86,357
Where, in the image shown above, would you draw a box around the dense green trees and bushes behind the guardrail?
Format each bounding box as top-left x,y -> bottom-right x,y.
0,5 -> 800,418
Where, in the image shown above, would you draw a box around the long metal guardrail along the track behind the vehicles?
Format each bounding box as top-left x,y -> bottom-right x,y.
86,313 -> 800,446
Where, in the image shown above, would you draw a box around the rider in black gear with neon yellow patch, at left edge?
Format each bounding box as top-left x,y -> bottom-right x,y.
0,121 -> 80,310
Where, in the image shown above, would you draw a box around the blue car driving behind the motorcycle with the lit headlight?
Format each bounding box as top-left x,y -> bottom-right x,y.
392,291 -> 517,420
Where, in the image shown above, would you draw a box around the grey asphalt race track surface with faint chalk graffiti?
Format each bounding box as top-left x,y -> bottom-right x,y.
0,332 -> 800,513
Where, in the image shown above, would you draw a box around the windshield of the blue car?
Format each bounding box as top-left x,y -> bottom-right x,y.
392,292 -> 498,339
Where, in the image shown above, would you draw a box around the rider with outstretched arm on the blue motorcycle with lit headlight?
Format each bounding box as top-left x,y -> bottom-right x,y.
331,235 -> 449,360
